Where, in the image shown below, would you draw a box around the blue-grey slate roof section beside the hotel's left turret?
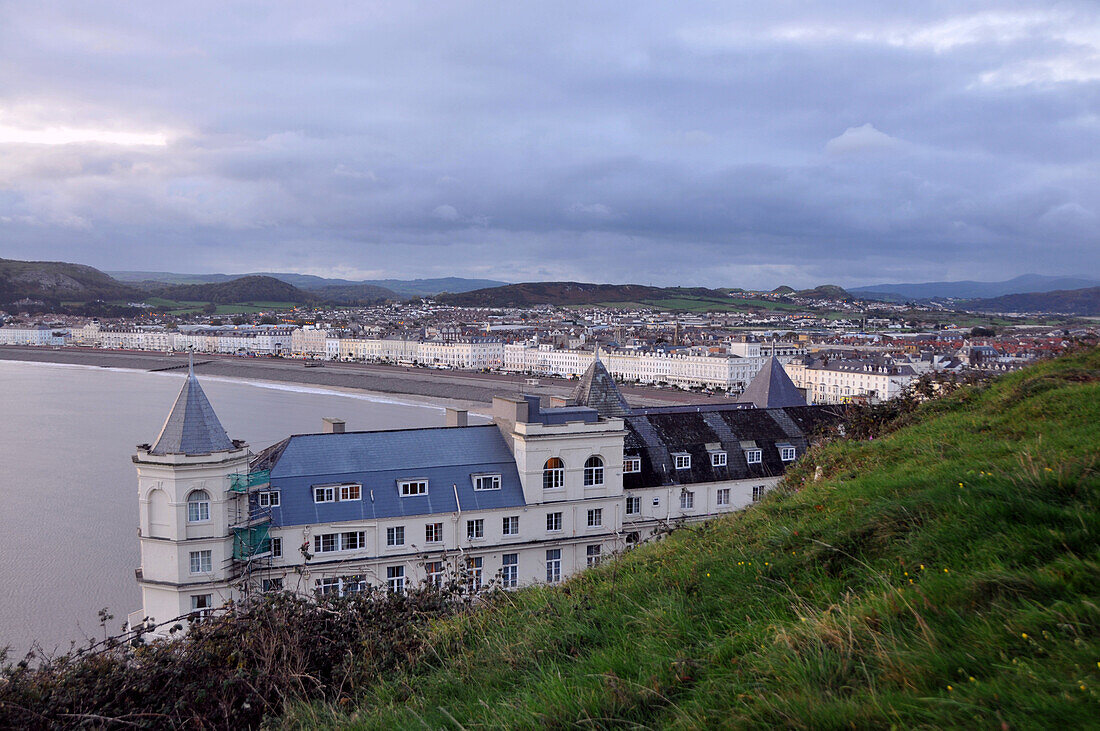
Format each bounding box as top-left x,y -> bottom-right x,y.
252,424 -> 525,525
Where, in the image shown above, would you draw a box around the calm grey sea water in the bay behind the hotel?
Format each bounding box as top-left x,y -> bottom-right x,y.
0,361 -> 459,650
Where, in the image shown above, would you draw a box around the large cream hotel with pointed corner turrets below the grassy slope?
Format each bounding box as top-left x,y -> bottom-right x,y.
129,359 -> 838,628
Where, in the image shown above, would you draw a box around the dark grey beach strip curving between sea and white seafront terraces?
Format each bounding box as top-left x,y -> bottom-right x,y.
0,345 -> 704,410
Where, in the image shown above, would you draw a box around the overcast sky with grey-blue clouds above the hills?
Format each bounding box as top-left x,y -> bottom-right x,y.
0,0 -> 1100,287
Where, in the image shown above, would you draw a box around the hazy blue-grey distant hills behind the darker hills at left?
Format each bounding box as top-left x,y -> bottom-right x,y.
107,272 -> 507,299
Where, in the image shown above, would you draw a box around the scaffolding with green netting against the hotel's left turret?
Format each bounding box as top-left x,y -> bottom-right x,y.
227,469 -> 274,601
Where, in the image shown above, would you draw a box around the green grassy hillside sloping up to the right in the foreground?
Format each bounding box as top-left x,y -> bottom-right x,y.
286,350 -> 1100,729
